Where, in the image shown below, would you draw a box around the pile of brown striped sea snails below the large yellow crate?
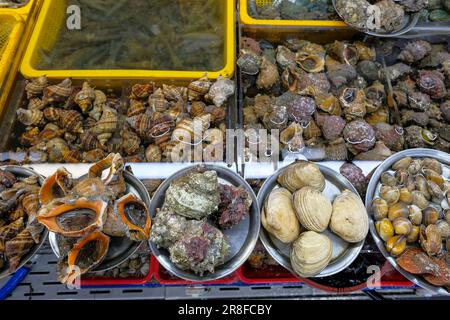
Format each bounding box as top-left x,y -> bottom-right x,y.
16,75 -> 235,163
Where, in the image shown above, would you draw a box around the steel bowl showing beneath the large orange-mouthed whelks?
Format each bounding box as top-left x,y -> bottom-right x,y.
48,171 -> 150,272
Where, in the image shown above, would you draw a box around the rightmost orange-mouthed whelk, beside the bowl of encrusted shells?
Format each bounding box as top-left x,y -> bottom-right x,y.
114,193 -> 151,241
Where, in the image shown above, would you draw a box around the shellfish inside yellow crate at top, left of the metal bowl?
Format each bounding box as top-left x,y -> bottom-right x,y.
246,0 -> 338,20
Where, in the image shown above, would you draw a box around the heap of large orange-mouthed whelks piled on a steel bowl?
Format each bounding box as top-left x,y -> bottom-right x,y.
37,153 -> 151,283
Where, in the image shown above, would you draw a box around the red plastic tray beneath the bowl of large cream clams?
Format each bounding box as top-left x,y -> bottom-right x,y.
237,261 -> 414,289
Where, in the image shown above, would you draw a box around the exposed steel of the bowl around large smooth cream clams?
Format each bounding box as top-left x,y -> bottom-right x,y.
258,164 -> 364,278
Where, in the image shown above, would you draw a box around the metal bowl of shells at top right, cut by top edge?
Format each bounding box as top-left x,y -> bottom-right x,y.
333,0 -> 421,37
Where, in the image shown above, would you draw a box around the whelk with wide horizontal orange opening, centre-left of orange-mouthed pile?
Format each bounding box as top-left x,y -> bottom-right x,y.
37,198 -> 108,237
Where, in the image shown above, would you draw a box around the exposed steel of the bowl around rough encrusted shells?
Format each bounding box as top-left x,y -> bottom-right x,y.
150,164 -> 261,282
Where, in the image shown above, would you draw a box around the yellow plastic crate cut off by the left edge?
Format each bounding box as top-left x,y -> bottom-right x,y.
0,9 -> 24,92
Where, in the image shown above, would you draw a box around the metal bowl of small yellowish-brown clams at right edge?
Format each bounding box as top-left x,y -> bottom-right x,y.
366,149 -> 450,295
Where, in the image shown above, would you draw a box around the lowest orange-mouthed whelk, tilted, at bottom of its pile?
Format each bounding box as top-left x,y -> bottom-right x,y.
58,232 -> 110,284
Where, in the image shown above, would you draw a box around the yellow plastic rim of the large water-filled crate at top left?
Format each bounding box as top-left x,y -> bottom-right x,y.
20,0 -> 236,80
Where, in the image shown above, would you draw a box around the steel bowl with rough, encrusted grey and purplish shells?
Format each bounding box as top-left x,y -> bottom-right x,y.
150,164 -> 260,282
